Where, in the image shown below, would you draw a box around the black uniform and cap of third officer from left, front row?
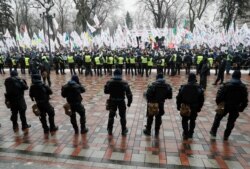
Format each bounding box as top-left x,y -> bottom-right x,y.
61,75 -> 88,134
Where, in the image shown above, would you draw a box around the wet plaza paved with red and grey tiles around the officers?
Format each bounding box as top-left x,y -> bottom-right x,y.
0,70 -> 250,169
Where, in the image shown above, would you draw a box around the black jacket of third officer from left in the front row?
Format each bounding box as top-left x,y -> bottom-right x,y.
61,81 -> 85,104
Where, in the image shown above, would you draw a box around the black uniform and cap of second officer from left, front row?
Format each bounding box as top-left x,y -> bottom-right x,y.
29,75 -> 58,133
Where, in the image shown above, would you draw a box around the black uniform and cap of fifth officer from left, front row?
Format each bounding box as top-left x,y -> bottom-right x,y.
143,74 -> 173,136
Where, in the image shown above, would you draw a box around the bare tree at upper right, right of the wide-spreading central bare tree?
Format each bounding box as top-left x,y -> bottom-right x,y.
187,0 -> 213,31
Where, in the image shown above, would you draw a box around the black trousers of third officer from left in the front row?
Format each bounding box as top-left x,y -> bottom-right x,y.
70,103 -> 86,132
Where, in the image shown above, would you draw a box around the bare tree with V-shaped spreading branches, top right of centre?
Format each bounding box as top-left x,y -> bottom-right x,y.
139,0 -> 176,28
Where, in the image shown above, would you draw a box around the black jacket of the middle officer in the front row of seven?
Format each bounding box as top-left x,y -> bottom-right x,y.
104,78 -> 133,105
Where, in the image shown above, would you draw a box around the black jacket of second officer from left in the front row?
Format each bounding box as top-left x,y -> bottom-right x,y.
29,80 -> 52,103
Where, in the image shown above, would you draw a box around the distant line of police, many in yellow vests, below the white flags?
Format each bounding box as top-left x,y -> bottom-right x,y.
0,49 -> 250,77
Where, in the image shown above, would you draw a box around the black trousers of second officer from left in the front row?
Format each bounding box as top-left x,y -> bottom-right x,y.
37,102 -> 56,132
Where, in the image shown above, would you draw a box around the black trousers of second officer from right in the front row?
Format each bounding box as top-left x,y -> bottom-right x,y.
181,111 -> 198,136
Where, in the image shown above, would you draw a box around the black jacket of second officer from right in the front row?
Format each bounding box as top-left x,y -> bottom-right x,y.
176,82 -> 204,112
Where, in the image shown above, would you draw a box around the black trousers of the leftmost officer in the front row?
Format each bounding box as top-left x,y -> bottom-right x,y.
10,98 -> 28,129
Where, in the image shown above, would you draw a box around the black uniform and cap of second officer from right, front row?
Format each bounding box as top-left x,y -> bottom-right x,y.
176,73 -> 204,139
